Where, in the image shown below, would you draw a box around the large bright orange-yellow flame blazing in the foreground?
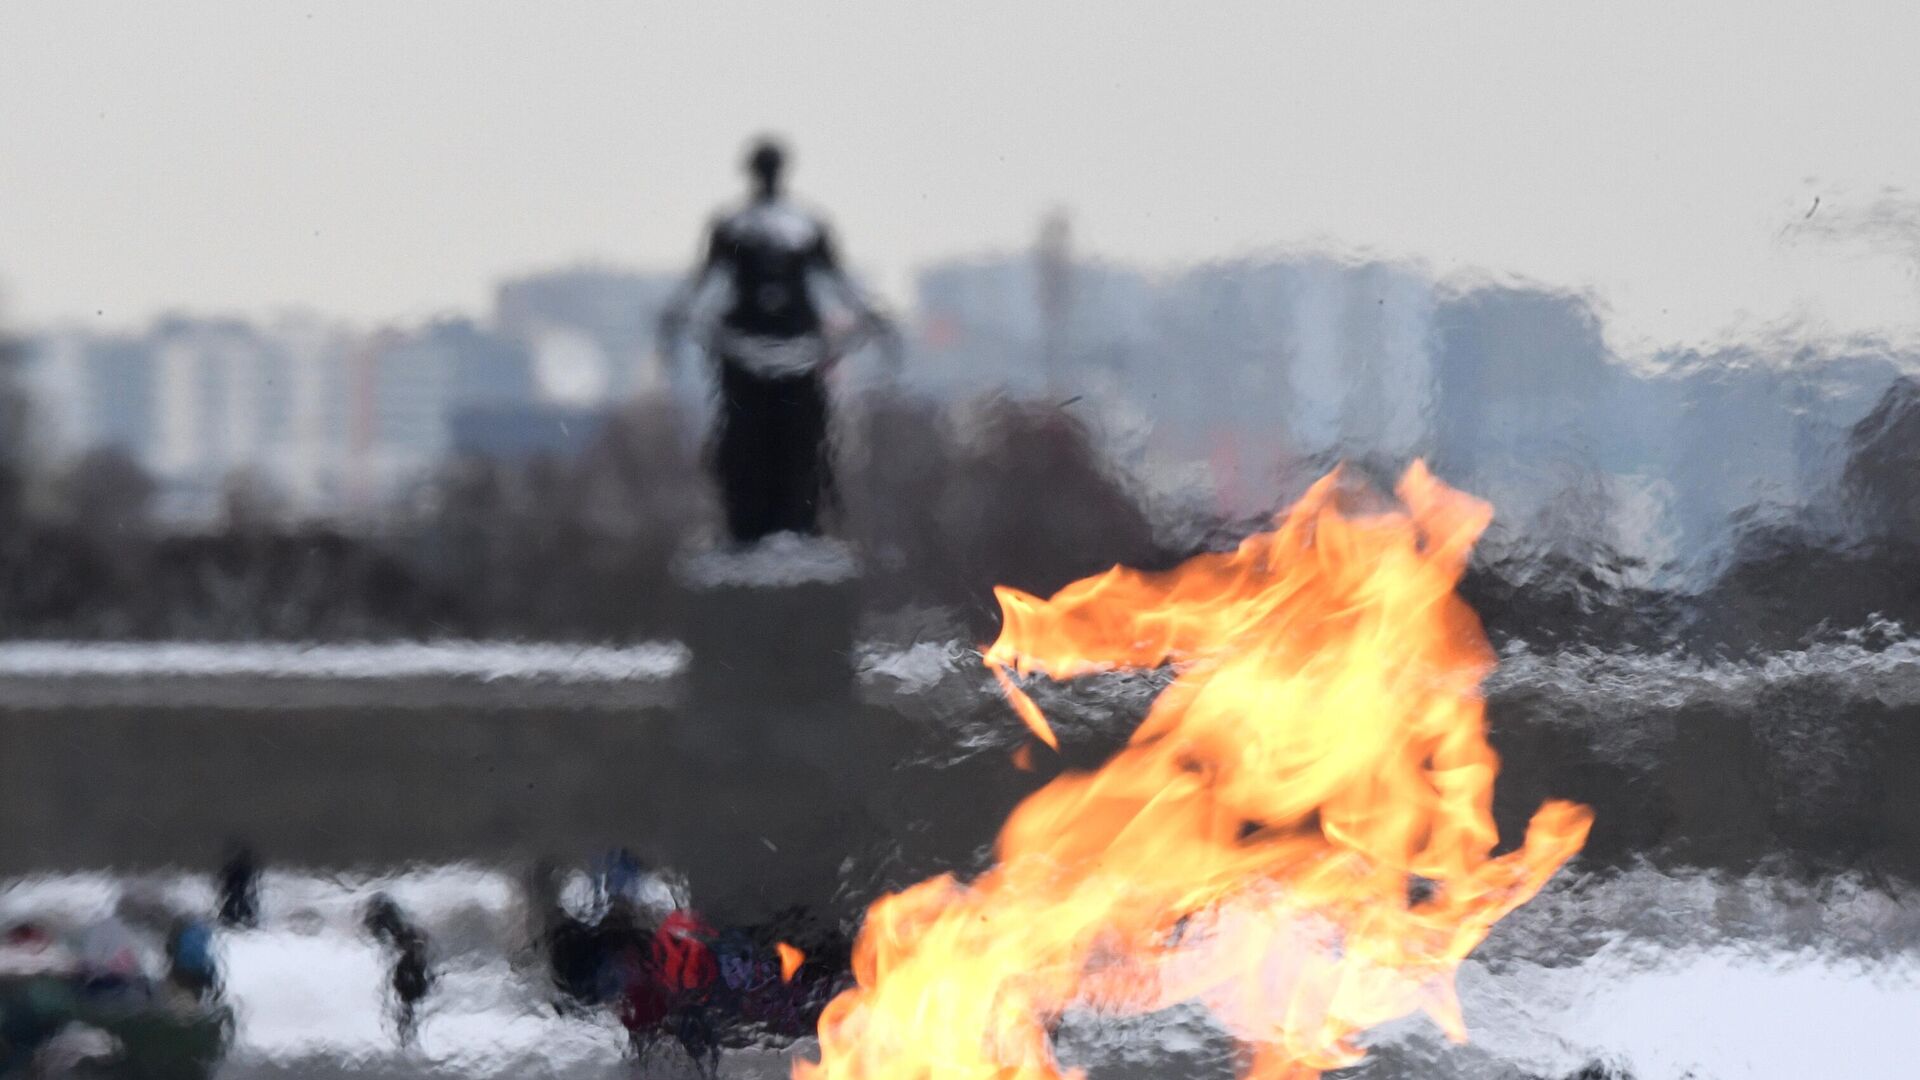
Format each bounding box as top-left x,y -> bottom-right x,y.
795,465 -> 1592,1080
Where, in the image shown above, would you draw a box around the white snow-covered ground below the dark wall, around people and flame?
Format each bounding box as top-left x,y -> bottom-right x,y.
0,867 -> 1920,1080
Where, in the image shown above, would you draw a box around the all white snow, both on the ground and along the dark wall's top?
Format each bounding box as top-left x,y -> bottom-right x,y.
0,642 -> 1920,1080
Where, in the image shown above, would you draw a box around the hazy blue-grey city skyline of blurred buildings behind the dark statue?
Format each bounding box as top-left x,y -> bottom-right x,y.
27,250 -> 1920,575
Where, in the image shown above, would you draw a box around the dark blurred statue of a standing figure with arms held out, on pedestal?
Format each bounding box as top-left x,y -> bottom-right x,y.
660,138 -> 891,544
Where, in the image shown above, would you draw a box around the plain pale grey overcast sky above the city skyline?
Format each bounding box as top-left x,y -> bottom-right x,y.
0,0 -> 1920,348
